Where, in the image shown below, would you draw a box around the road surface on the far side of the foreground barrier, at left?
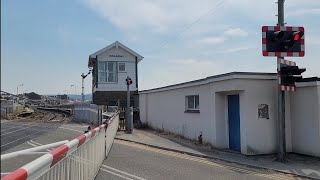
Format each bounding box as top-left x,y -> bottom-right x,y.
1,121 -> 87,172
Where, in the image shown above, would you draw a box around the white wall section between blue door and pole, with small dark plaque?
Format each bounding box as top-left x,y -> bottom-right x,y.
235,80 -> 278,155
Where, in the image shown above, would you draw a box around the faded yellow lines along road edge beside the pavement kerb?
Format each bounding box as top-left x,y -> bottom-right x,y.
114,140 -> 295,180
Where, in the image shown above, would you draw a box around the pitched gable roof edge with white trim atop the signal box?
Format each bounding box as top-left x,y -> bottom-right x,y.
88,41 -> 143,67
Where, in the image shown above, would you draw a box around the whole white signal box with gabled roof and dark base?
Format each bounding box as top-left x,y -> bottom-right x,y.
88,41 -> 143,107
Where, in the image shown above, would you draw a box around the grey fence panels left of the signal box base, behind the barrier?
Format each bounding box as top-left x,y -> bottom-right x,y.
74,103 -> 101,125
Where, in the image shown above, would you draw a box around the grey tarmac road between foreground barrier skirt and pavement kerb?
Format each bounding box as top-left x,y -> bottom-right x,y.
96,140 -> 295,180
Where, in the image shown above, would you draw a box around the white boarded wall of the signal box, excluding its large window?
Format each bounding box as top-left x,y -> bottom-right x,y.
93,46 -> 137,91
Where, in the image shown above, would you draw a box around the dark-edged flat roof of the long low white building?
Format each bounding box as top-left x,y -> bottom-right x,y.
139,72 -> 278,94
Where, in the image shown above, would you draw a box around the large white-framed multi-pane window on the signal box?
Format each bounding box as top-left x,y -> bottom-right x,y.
98,62 -> 117,82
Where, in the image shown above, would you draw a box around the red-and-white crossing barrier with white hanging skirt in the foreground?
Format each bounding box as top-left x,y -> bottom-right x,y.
3,112 -> 119,180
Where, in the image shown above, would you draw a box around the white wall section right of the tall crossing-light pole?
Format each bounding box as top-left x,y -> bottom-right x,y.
290,82 -> 320,157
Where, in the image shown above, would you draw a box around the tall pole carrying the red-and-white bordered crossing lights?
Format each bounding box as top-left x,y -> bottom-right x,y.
278,0 -> 286,162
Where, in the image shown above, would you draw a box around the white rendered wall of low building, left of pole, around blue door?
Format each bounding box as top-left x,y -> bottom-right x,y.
140,79 -> 277,154
